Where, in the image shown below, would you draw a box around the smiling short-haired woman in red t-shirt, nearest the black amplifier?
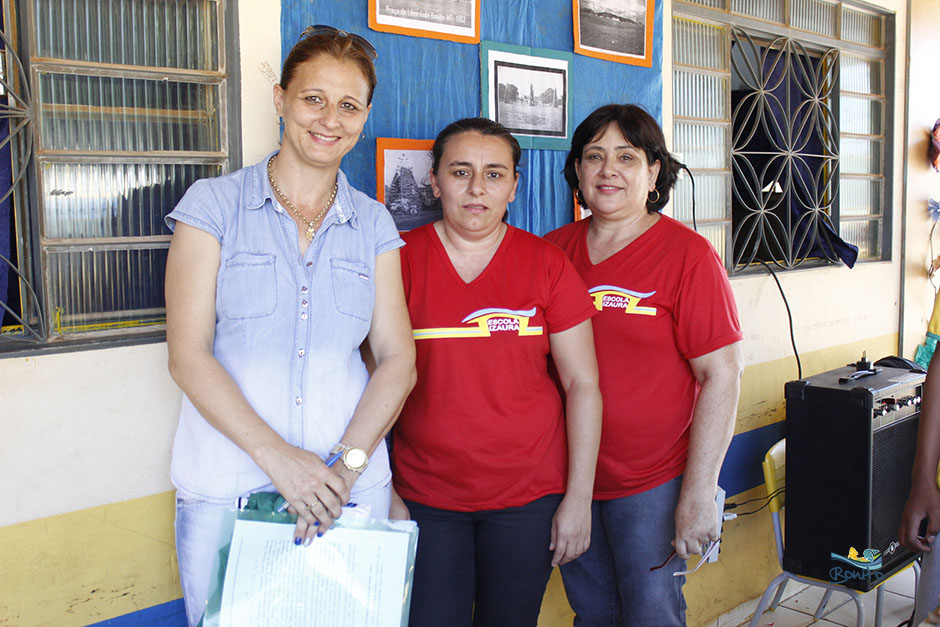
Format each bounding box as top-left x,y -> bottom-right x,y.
546,104 -> 743,627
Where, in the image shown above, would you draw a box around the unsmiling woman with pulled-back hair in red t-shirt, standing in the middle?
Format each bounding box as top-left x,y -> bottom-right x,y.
392,118 -> 601,627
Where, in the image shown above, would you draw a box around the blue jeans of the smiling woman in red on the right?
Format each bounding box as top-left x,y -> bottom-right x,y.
561,477 -> 685,627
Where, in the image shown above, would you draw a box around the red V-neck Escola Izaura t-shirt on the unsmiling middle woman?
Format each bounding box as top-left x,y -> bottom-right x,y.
392,224 -> 597,511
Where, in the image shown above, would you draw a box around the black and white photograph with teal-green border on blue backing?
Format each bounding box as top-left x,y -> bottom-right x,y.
482,42 -> 570,149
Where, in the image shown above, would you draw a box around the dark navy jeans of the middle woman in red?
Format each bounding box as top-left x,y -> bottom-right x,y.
405,494 -> 561,627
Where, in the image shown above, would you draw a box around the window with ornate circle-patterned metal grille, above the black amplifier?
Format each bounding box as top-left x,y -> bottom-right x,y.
673,0 -> 894,273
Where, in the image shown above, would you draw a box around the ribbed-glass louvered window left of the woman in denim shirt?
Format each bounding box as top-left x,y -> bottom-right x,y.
0,0 -> 230,349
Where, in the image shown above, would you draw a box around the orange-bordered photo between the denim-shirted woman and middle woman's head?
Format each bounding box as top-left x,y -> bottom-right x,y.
376,137 -> 443,231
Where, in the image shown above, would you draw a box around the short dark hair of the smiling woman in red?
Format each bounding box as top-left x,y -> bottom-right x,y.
564,104 -> 682,213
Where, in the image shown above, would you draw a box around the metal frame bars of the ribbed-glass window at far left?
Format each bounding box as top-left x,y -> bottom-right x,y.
0,0 -> 242,358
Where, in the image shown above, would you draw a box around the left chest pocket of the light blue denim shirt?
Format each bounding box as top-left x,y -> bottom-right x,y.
219,252 -> 277,320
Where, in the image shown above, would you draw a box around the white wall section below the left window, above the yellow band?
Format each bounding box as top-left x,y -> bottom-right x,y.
0,344 -> 179,526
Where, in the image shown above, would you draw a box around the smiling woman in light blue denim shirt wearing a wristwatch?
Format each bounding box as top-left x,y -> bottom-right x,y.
166,26 -> 415,624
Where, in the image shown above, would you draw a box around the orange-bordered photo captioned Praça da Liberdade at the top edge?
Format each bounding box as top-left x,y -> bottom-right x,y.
369,0 -> 480,43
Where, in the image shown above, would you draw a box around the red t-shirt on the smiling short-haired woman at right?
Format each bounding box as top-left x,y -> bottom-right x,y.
545,216 -> 741,499
